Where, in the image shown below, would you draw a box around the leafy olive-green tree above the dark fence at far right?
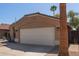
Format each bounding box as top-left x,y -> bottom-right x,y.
68,10 -> 79,30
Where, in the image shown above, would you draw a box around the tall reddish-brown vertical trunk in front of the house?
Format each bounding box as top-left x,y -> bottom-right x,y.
59,3 -> 68,56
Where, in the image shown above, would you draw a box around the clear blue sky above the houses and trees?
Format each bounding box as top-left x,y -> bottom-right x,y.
0,3 -> 79,24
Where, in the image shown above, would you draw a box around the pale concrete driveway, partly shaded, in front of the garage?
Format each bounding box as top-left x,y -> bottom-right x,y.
0,40 -> 58,56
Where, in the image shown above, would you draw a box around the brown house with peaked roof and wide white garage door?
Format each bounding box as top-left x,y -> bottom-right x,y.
10,13 -> 71,46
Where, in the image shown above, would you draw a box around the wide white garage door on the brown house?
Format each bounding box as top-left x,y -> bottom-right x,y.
20,27 -> 56,46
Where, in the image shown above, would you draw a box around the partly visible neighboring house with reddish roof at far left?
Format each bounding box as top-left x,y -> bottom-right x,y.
0,24 -> 10,39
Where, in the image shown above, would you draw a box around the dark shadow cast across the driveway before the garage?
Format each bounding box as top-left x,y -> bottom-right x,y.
1,41 -> 58,54
